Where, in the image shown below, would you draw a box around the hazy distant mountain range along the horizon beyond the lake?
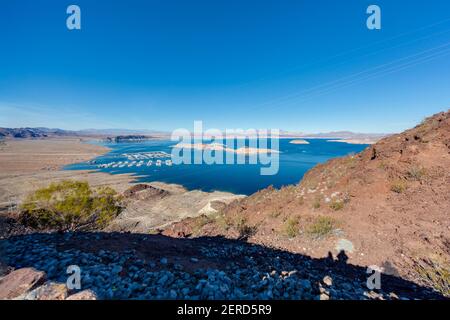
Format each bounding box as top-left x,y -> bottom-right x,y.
0,127 -> 387,139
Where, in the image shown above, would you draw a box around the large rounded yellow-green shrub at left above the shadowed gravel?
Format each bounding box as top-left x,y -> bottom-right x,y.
20,180 -> 121,230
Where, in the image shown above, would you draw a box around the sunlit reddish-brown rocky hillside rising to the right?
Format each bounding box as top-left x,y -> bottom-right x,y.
165,111 -> 450,295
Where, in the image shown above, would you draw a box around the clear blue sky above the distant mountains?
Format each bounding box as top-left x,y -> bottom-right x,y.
0,0 -> 450,132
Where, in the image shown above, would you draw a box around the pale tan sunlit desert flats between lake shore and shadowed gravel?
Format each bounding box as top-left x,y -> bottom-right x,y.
0,138 -> 242,233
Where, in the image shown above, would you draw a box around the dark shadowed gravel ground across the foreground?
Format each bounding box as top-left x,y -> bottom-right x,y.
0,233 -> 441,300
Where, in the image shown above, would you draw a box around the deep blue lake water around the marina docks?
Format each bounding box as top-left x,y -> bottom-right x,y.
65,139 -> 367,195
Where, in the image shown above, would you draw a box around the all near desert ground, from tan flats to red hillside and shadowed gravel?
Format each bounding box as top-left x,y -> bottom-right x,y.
0,112 -> 450,300
